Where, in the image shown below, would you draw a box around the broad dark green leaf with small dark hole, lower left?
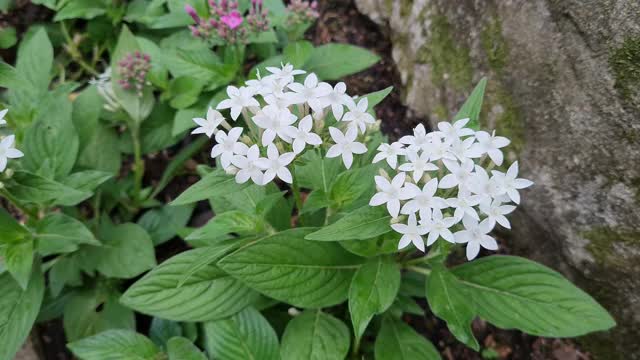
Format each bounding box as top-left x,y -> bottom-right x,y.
63,289 -> 136,341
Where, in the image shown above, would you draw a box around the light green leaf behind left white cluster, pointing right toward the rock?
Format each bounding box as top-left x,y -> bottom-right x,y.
306,44 -> 380,80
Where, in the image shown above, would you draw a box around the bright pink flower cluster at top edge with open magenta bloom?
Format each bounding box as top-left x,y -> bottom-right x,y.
185,0 -> 269,44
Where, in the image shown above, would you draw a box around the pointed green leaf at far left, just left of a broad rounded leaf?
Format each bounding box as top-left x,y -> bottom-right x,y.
35,213 -> 101,256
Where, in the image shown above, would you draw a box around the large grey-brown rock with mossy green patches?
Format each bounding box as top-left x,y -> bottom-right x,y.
356,0 -> 640,359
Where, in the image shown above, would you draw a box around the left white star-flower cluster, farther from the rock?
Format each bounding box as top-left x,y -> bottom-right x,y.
192,64 -> 375,185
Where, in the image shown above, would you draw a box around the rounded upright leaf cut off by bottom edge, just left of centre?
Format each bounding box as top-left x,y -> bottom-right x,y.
280,310 -> 350,360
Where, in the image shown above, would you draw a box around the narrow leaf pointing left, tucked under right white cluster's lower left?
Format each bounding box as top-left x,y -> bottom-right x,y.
305,205 -> 391,241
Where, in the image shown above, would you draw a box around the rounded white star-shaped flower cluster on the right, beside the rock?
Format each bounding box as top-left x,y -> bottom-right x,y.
369,119 -> 533,260
